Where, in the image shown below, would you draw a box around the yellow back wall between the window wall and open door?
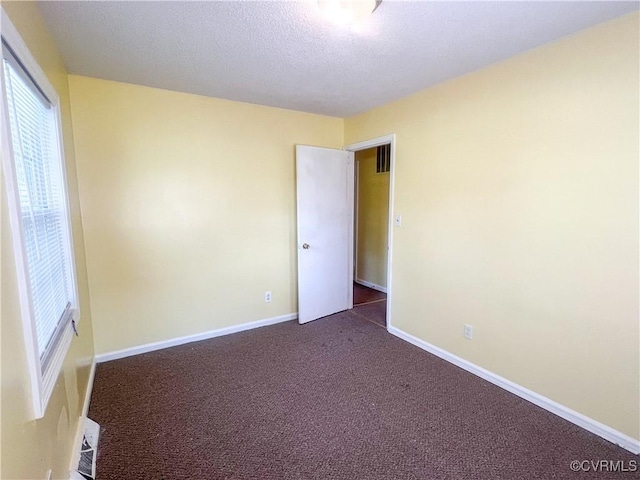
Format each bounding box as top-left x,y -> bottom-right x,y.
69,75 -> 344,353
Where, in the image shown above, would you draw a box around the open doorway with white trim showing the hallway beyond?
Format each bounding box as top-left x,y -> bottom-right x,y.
345,135 -> 395,328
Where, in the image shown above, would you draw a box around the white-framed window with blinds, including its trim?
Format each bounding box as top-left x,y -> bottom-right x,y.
1,18 -> 78,417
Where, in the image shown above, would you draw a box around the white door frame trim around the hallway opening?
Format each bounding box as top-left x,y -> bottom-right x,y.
342,133 -> 396,330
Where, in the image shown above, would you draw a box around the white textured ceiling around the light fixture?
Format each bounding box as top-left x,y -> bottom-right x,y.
38,0 -> 639,117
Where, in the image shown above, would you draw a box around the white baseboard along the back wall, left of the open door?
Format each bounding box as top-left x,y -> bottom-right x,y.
96,313 -> 298,363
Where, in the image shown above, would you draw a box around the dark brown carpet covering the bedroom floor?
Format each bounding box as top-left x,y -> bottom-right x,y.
90,312 -> 638,480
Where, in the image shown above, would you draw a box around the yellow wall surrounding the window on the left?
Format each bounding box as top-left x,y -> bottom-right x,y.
0,1 -> 93,480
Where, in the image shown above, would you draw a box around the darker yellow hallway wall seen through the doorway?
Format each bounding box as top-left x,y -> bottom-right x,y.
356,148 -> 389,288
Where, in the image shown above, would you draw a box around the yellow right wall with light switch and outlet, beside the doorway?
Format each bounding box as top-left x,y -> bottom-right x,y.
345,13 -> 640,439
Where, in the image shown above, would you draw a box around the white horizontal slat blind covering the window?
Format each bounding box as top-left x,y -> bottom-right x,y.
2,41 -> 75,376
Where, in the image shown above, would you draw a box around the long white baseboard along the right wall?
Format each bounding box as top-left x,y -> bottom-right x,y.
388,326 -> 640,455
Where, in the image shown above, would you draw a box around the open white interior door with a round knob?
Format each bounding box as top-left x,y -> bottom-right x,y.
296,145 -> 354,323
